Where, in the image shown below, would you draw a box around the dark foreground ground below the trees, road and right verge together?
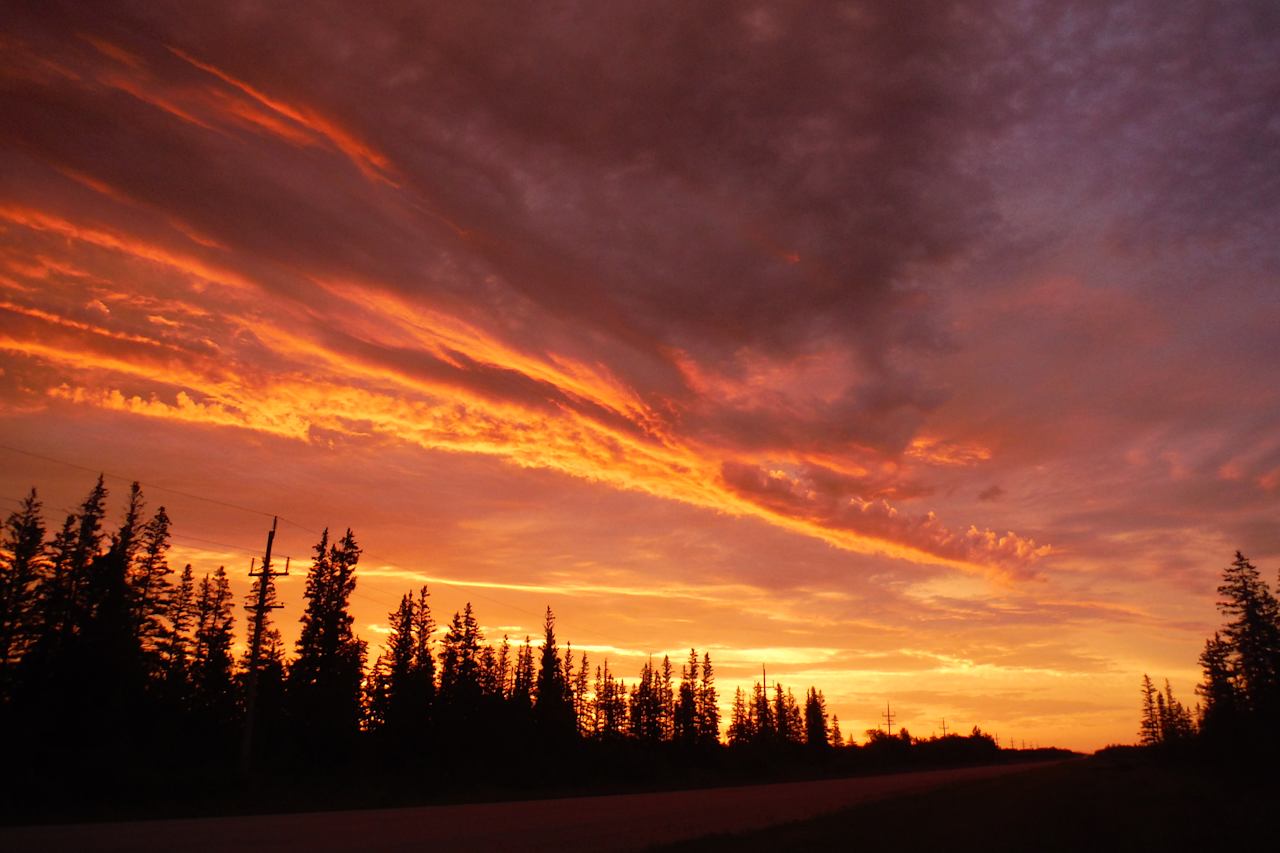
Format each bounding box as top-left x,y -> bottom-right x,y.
0,752 -> 1280,853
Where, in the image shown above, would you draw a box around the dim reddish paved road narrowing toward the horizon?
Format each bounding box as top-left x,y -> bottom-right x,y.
0,765 -> 1059,853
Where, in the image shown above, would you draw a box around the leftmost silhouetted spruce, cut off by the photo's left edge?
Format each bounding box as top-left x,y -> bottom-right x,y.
0,488 -> 49,691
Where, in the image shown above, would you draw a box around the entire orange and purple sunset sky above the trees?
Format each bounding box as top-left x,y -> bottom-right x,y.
0,0 -> 1280,749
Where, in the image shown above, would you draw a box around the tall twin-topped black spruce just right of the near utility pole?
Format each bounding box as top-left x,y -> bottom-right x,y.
287,529 -> 365,763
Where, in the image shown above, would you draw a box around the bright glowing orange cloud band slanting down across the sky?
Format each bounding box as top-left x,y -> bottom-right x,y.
0,199 -> 1048,576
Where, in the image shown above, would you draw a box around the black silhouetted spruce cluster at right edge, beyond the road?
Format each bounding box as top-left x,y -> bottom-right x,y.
1139,551 -> 1280,757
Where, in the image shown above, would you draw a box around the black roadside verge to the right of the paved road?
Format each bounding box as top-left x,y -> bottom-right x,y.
657,753 -> 1280,853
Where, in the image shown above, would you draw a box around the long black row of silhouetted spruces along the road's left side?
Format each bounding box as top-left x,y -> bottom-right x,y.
0,476 -> 1024,818
